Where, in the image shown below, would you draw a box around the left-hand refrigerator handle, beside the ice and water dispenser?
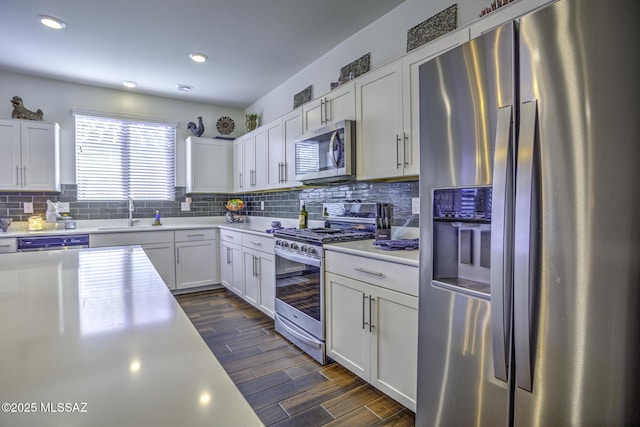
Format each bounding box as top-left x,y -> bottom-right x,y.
491,105 -> 513,381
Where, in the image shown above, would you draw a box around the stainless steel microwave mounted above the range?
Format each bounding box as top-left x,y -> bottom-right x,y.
295,120 -> 356,184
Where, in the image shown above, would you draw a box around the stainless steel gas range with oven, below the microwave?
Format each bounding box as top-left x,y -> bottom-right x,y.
274,202 -> 380,365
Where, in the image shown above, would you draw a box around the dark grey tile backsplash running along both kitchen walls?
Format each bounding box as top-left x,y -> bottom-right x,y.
0,180 -> 419,227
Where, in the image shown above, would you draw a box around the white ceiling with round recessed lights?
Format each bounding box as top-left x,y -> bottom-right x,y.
0,0 -> 404,108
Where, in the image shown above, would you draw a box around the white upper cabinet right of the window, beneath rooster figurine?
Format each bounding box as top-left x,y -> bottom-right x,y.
186,136 -> 233,193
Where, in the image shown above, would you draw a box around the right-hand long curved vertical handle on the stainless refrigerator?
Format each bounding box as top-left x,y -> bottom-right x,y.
513,101 -> 538,391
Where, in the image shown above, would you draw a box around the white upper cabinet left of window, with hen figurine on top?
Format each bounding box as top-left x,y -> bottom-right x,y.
0,119 -> 60,191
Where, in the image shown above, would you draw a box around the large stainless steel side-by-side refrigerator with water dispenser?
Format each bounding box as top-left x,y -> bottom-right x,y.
417,0 -> 640,427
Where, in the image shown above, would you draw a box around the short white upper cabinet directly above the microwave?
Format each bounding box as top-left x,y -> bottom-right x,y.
302,82 -> 355,133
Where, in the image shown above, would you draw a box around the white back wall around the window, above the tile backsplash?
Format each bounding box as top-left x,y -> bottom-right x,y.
0,71 -> 245,186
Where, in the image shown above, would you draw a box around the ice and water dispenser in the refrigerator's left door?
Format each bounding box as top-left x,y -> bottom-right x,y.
432,187 -> 491,299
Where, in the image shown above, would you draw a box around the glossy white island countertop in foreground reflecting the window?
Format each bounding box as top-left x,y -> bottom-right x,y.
0,247 -> 262,427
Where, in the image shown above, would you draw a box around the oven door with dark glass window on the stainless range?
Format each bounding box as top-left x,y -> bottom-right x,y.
275,247 -> 324,341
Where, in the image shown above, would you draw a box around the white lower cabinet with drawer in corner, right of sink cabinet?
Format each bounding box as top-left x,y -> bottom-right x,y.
175,229 -> 220,289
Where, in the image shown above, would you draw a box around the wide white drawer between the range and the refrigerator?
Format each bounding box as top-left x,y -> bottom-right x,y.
325,251 -> 418,296
